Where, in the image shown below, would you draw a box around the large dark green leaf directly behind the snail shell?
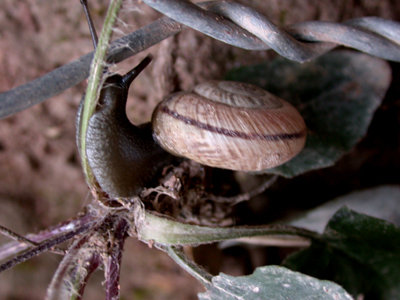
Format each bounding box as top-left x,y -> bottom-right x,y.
226,51 -> 391,177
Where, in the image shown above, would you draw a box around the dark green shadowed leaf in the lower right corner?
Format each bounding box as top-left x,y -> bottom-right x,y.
284,207 -> 400,300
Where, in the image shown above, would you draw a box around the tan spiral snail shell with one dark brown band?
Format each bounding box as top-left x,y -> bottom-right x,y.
152,81 -> 306,171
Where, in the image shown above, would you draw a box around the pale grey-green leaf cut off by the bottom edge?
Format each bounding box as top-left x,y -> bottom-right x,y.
199,266 -> 353,300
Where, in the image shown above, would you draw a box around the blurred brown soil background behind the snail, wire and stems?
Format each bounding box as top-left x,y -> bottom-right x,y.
0,0 -> 400,300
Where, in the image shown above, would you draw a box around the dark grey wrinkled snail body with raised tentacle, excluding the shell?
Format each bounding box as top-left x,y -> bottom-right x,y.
77,57 -> 174,199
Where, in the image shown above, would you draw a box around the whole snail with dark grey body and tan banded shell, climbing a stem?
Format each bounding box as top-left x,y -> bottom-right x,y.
77,0 -> 306,199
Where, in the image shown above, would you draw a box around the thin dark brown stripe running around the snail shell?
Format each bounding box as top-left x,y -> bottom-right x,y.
162,106 -> 306,141
